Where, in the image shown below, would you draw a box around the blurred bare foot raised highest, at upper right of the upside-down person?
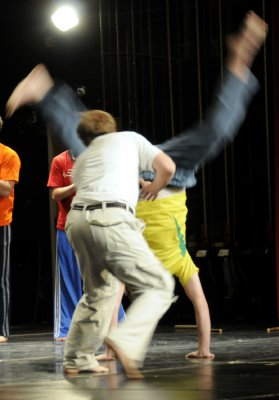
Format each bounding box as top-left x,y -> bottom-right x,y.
227,11 -> 268,80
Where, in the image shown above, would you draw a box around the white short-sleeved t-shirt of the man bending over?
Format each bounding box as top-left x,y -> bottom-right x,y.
73,132 -> 161,207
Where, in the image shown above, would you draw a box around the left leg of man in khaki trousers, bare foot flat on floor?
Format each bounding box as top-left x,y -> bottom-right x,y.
64,210 -> 119,373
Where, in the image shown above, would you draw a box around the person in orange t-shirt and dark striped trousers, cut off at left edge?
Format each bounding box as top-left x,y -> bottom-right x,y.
0,117 -> 21,344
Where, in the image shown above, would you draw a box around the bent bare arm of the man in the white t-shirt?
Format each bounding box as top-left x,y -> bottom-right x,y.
140,151 -> 175,200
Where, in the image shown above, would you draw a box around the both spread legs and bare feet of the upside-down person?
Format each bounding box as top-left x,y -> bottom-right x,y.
6,12 -> 268,167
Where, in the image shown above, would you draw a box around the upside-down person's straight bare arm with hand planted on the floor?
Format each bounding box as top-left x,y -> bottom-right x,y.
184,273 -> 215,359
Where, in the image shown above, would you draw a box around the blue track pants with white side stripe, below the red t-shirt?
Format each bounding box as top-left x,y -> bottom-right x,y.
54,230 -> 82,341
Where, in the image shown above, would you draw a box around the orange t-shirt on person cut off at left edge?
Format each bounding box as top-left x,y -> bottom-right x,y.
0,143 -> 21,226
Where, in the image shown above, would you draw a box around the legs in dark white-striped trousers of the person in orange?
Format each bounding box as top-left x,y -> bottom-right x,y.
0,225 -> 11,344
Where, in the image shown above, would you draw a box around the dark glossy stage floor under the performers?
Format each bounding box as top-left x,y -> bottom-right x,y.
0,326 -> 279,400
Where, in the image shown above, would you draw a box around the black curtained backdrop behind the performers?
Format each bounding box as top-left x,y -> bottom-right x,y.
0,0 -> 277,325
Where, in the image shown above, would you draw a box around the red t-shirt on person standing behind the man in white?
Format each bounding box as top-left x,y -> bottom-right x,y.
47,150 -> 75,230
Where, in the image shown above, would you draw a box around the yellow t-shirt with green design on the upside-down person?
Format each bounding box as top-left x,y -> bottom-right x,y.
136,191 -> 199,286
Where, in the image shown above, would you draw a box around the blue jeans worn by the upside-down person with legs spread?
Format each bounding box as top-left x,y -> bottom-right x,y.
36,70 -> 258,188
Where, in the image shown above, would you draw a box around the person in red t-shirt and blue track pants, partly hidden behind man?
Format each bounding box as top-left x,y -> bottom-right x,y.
47,150 -> 82,341
